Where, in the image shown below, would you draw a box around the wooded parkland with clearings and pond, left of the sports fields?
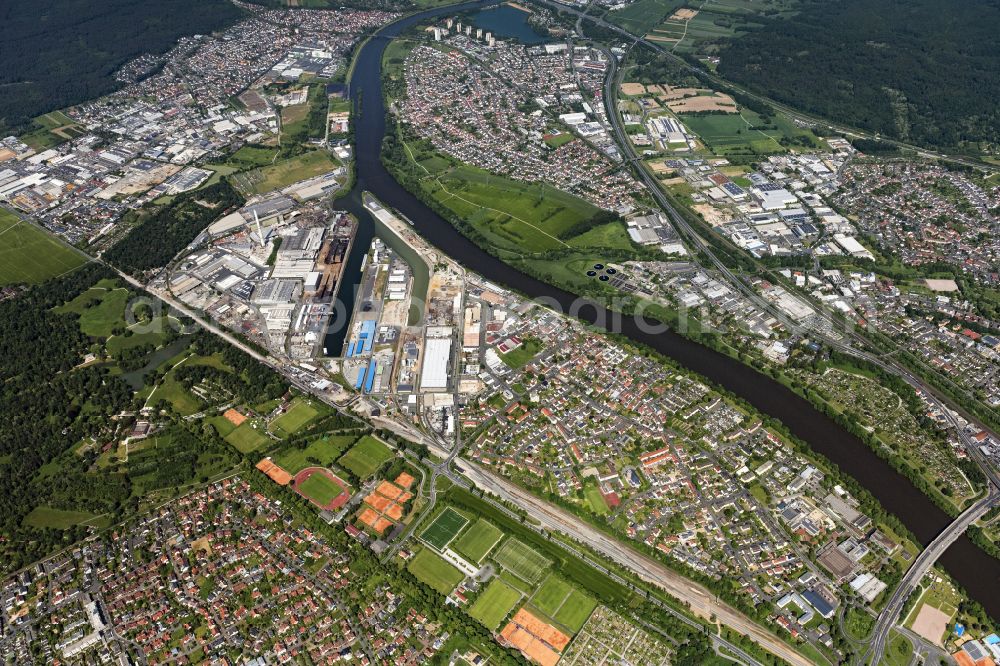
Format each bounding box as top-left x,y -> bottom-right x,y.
0,263 -> 289,571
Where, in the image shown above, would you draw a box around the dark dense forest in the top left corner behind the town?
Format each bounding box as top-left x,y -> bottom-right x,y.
0,0 -> 242,133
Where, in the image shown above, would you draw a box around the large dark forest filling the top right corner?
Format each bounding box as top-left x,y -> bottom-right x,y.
719,0 -> 1000,149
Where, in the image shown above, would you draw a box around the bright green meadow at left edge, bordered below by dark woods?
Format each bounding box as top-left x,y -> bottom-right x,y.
0,208 -> 84,285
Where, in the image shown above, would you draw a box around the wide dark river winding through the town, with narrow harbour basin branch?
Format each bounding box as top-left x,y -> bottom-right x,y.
338,0 -> 1000,618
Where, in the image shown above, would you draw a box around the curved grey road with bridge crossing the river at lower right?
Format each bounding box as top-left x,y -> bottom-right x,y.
859,486 -> 1000,664
